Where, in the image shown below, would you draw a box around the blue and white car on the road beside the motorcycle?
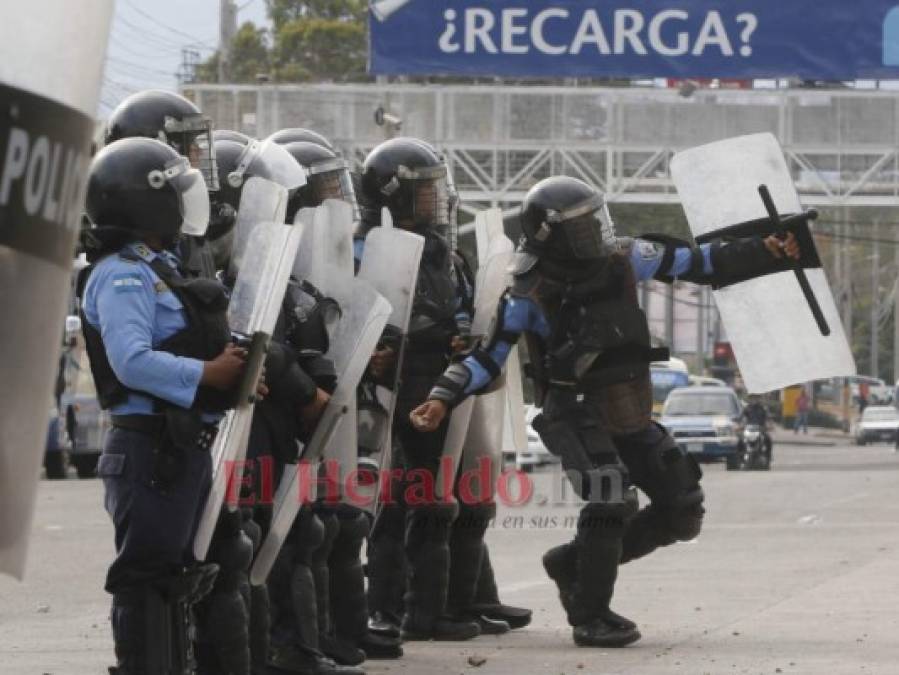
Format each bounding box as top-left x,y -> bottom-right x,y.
661,387 -> 742,462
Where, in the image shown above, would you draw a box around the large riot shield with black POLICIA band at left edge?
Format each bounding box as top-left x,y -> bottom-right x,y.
0,0 -> 113,579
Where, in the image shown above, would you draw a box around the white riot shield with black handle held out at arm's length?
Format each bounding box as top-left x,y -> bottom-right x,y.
671,133 -> 856,393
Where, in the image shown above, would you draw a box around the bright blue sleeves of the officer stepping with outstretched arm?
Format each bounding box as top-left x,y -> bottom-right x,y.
462,239 -> 712,395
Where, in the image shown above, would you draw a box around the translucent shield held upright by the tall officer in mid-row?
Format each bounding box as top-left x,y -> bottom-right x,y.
357,225 -> 424,513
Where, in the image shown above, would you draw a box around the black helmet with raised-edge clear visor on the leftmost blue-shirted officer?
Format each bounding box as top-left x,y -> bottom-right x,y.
85,138 -> 209,240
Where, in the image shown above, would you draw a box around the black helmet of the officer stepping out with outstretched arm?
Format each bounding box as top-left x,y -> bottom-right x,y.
521,176 -> 617,262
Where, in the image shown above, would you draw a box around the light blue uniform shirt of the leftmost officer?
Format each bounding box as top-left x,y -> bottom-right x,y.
83,244 -> 203,415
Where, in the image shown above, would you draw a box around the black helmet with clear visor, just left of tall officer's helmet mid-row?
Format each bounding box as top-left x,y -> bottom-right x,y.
284,141 -> 359,223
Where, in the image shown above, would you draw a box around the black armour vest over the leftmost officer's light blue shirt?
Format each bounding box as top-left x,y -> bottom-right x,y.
78,253 -> 233,412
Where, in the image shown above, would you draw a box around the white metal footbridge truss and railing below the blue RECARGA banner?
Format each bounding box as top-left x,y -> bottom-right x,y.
184,84 -> 899,217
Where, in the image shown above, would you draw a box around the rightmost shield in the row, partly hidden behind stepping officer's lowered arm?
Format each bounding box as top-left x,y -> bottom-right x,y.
436,209 -> 514,498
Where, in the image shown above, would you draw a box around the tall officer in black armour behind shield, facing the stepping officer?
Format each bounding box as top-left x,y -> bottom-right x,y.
357,138 -> 480,640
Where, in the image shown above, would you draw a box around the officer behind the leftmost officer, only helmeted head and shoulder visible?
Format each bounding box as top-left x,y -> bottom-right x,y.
106,89 -> 224,279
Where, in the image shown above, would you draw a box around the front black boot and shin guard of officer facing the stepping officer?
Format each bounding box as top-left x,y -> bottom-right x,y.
402,503 -> 481,640
